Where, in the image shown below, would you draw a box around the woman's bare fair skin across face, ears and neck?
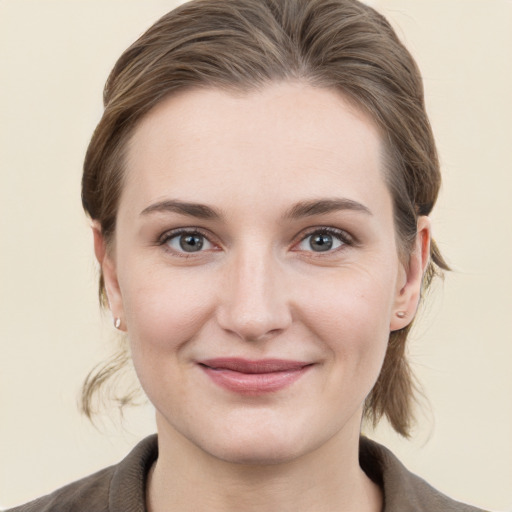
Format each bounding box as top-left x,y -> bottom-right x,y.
94,83 -> 430,512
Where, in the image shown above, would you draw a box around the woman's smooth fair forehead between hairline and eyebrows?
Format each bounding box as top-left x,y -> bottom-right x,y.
123,83 -> 383,214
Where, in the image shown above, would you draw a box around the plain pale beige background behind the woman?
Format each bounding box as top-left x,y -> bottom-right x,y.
0,0 -> 512,511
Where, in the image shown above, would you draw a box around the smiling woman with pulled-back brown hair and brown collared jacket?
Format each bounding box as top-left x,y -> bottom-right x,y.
5,0 -> 492,512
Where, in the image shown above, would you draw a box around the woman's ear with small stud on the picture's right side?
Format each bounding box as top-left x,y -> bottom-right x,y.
390,216 -> 432,331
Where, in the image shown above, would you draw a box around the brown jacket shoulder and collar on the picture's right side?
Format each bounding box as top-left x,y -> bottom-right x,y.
359,437 -> 484,512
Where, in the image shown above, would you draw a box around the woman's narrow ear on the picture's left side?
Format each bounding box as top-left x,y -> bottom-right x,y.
92,221 -> 124,330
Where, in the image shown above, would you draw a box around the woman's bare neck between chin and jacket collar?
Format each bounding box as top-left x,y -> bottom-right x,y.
147,416 -> 382,512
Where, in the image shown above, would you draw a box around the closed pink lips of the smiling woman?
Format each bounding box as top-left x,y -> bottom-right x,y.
199,358 -> 313,396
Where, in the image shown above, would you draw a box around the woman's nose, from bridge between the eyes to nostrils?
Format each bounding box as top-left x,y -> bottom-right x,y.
217,246 -> 292,341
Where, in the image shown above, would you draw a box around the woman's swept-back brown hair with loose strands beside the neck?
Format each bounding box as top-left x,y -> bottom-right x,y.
82,0 -> 448,436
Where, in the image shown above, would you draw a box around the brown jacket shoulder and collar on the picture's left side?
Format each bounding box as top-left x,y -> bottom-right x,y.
6,436 -> 158,512
